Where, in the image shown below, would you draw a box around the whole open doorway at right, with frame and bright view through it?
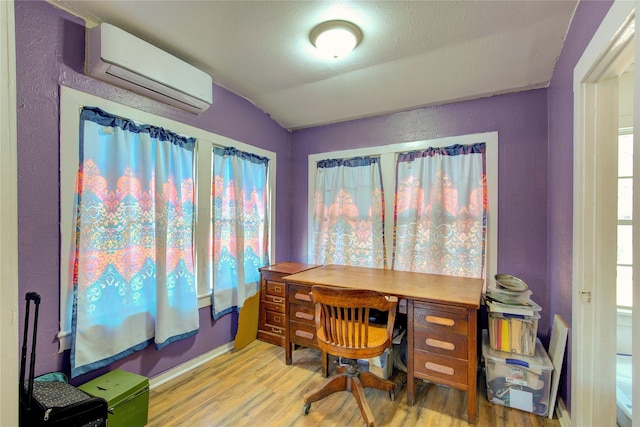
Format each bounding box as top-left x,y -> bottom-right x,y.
571,1 -> 640,427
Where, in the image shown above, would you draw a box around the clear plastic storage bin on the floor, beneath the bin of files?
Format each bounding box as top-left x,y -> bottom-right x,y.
482,330 -> 553,416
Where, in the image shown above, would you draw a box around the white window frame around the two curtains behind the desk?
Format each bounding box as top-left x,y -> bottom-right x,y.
308,132 -> 498,286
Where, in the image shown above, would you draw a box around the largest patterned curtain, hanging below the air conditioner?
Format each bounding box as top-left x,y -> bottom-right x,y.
71,108 -> 199,376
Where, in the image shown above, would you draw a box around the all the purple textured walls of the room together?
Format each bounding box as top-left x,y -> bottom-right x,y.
16,0 -> 611,416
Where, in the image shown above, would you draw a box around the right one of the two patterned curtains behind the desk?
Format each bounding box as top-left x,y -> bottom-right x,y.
393,143 -> 487,278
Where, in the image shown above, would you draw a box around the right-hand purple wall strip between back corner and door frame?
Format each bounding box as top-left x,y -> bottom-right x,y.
547,0 -> 612,409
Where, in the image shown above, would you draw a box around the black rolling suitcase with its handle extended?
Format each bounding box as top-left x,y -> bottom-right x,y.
20,292 -> 107,427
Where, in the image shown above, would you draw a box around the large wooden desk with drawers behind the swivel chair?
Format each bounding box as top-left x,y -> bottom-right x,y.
283,265 -> 483,423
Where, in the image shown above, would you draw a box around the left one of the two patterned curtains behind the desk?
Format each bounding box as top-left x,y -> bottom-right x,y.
312,157 -> 386,268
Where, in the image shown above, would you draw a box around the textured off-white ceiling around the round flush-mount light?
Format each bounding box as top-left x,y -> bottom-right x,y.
51,0 -> 577,129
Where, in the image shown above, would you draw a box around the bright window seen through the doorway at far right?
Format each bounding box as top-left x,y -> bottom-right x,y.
616,129 -> 633,308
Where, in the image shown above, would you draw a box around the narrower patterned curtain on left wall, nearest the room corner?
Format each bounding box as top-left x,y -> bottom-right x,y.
211,147 -> 269,319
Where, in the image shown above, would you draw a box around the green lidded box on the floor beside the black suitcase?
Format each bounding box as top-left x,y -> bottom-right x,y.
78,369 -> 149,427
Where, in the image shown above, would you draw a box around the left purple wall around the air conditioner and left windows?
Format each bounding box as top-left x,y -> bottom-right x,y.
15,0 -> 291,382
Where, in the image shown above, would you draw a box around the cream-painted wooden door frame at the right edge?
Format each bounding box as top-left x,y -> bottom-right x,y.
571,0 -> 640,426
